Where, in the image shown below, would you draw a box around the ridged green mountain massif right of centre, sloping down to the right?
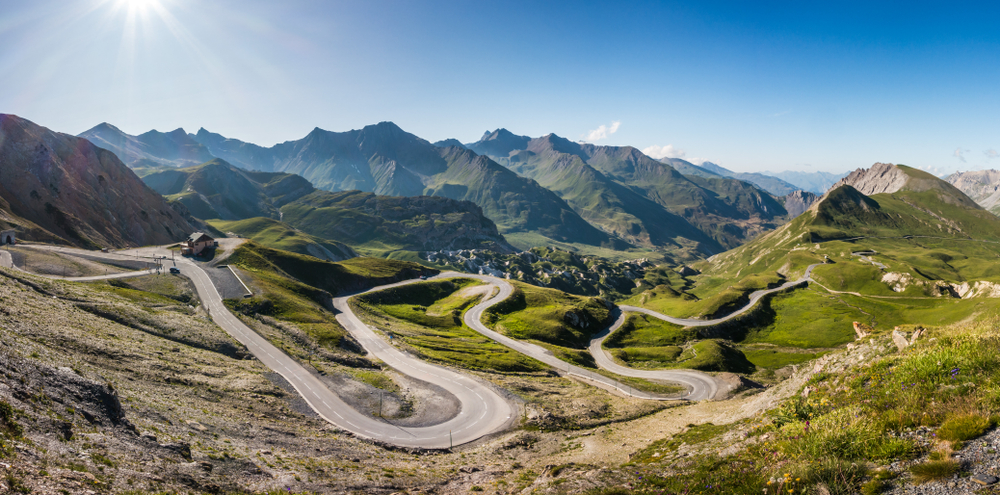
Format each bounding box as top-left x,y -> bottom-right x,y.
467,129 -> 786,254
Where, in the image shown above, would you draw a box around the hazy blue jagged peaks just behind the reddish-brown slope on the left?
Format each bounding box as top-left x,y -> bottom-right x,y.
78,123 -> 213,168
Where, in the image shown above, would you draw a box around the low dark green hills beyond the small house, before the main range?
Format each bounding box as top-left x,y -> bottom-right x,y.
143,158 -> 512,254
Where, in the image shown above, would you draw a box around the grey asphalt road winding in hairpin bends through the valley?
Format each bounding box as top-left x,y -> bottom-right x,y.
0,245 -> 817,448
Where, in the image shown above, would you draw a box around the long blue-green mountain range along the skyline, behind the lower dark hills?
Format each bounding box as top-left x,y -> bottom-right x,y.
81,122 -> 828,256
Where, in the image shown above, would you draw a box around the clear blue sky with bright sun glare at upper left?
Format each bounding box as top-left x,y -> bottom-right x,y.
0,0 -> 1000,173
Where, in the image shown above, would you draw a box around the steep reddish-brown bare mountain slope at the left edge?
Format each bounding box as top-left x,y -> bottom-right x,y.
0,114 -> 195,247
